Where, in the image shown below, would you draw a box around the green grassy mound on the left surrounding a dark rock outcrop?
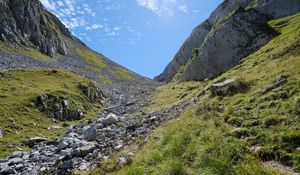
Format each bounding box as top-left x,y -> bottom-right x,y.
0,70 -> 101,156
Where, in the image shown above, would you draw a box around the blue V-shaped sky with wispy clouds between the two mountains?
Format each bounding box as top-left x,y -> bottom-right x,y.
40,0 -> 222,78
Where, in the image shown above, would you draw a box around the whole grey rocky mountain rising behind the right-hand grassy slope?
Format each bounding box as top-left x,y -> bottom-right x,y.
155,0 -> 300,82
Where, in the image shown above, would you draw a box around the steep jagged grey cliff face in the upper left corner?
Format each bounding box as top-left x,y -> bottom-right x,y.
0,0 -> 72,57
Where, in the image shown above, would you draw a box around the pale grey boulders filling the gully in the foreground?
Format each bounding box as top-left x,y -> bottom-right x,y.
0,91 -> 193,175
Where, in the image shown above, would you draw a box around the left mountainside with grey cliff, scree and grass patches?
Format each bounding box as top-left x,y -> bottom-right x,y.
0,0 -> 155,91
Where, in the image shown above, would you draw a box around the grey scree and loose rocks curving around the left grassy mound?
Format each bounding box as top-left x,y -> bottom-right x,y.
0,53 -> 193,175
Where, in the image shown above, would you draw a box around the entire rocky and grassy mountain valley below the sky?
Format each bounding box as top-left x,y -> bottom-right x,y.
0,0 -> 300,175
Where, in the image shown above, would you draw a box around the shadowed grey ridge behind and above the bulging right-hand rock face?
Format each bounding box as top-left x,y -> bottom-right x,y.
155,0 -> 300,82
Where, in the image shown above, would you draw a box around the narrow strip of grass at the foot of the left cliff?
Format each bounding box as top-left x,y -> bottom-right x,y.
0,41 -> 53,61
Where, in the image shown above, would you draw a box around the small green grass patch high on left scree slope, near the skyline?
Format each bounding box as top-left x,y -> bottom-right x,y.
75,48 -> 106,71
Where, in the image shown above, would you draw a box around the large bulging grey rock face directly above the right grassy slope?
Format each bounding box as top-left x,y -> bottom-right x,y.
179,8 -> 277,81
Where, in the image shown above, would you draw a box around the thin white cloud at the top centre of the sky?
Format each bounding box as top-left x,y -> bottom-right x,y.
137,0 -> 176,16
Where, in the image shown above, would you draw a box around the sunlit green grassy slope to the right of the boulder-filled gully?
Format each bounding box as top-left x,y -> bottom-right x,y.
91,14 -> 300,175
